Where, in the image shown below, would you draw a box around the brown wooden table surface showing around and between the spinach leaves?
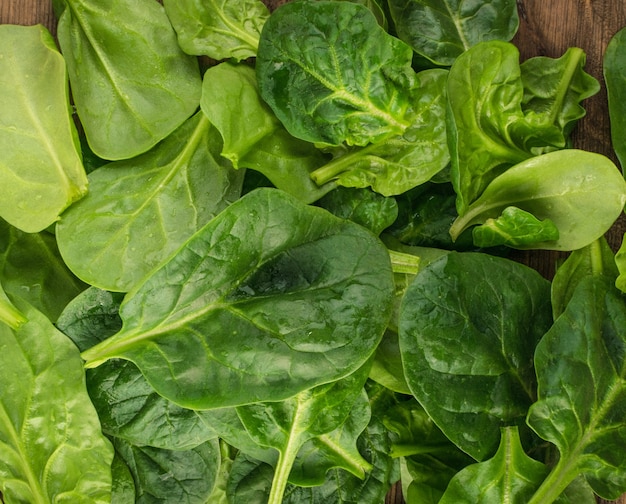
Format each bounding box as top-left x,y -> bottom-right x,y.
0,0 -> 626,504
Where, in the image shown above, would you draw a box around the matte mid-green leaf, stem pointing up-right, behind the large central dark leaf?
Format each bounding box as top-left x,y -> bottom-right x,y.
56,112 -> 243,292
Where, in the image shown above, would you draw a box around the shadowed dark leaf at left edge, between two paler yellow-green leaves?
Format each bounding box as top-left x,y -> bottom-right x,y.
0,219 -> 86,321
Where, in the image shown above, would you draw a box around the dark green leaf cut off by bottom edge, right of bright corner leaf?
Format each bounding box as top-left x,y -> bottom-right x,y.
114,439 -> 220,504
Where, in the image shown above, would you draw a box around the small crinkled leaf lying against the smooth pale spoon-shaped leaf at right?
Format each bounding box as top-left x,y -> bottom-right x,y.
472,206 -> 559,248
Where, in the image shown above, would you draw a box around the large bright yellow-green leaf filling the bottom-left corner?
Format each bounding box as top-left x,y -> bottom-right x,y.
0,298 -> 113,504
